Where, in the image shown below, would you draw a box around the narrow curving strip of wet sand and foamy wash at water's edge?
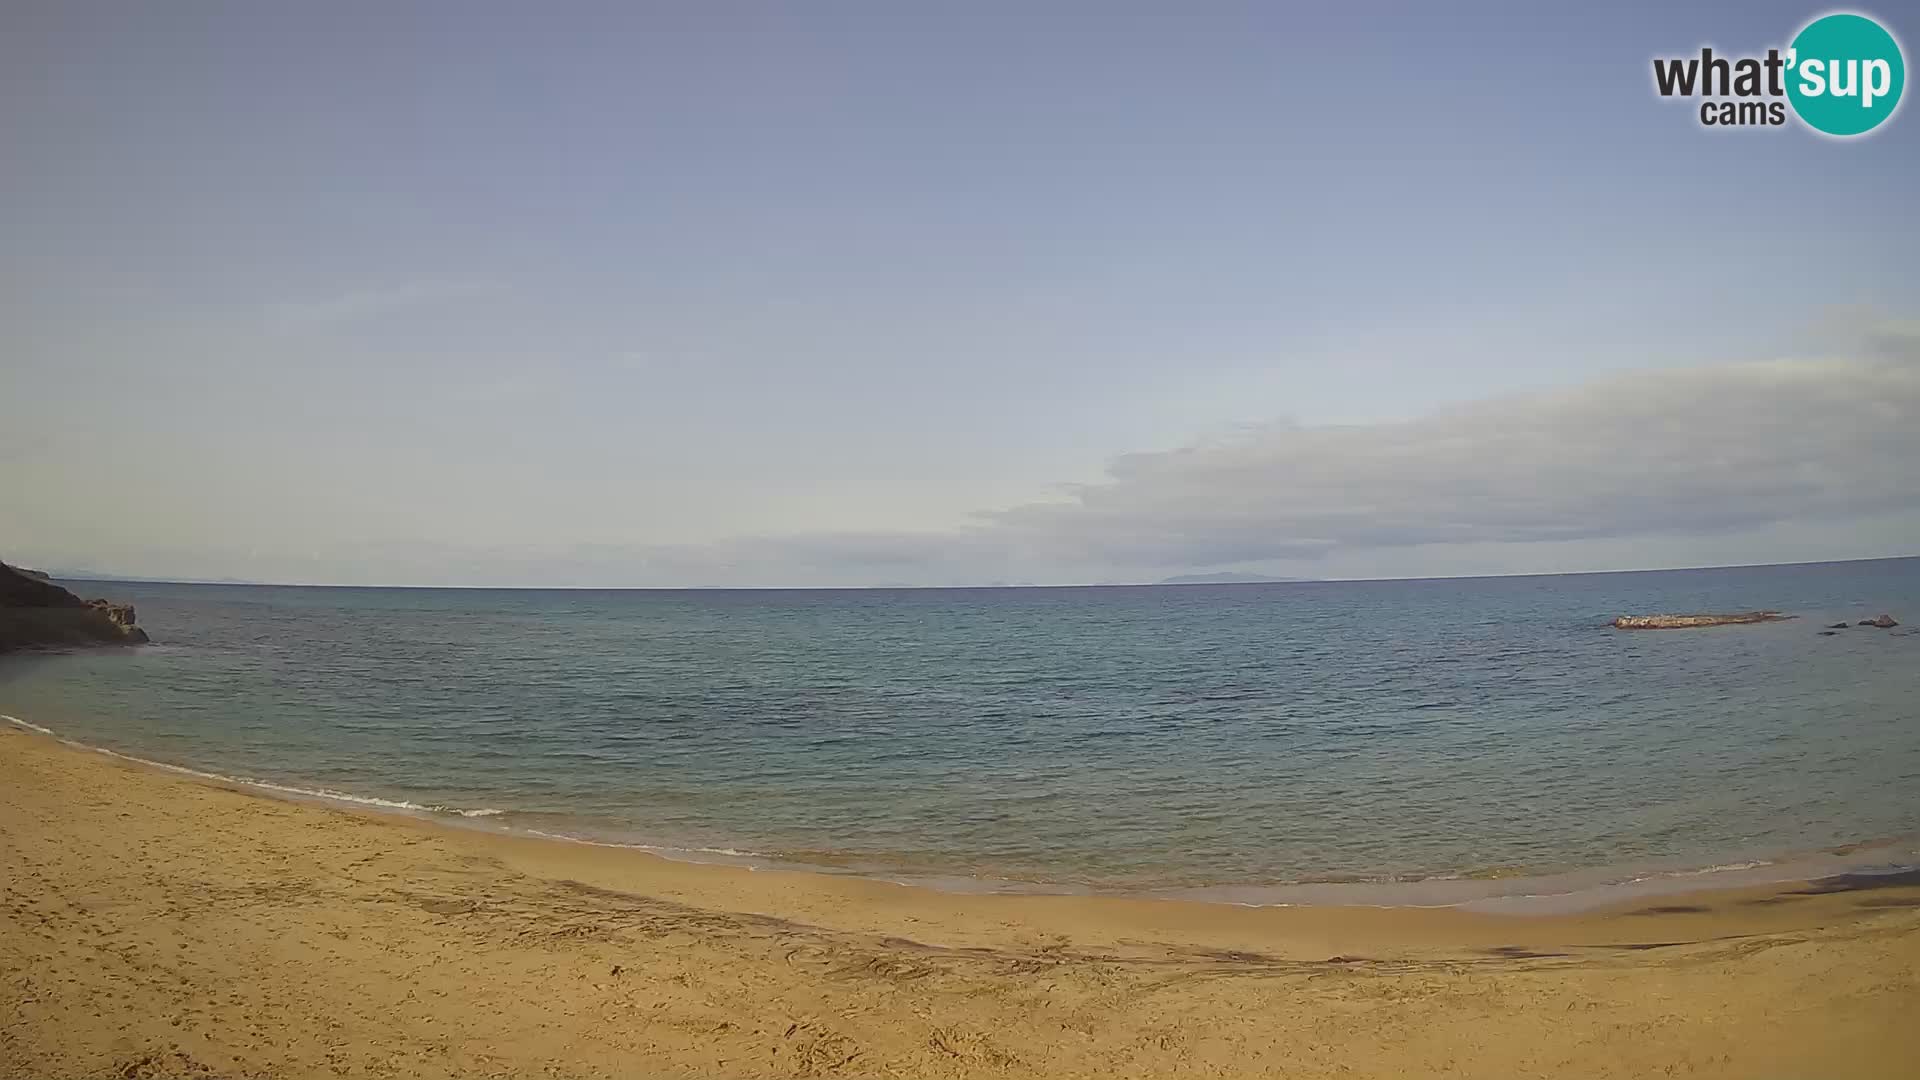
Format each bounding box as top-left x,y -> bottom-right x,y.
0,713 -> 1920,915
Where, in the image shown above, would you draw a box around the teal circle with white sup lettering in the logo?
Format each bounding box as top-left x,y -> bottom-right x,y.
1786,13 -> 1907,136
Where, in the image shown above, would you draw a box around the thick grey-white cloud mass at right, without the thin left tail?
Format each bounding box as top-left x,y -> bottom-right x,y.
985,334 -> 1920,567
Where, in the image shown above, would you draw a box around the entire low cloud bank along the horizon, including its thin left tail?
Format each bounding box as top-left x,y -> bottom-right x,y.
18,323 -> 1920,586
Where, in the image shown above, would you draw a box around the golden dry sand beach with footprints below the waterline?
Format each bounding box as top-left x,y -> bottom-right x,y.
0,718 -> 1920,1080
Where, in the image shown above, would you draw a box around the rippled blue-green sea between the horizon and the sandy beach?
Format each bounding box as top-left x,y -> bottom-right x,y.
0,559 -> 1920,890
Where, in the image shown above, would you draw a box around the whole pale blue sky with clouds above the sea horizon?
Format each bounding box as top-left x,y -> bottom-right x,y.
0,0 -> 1920,586
